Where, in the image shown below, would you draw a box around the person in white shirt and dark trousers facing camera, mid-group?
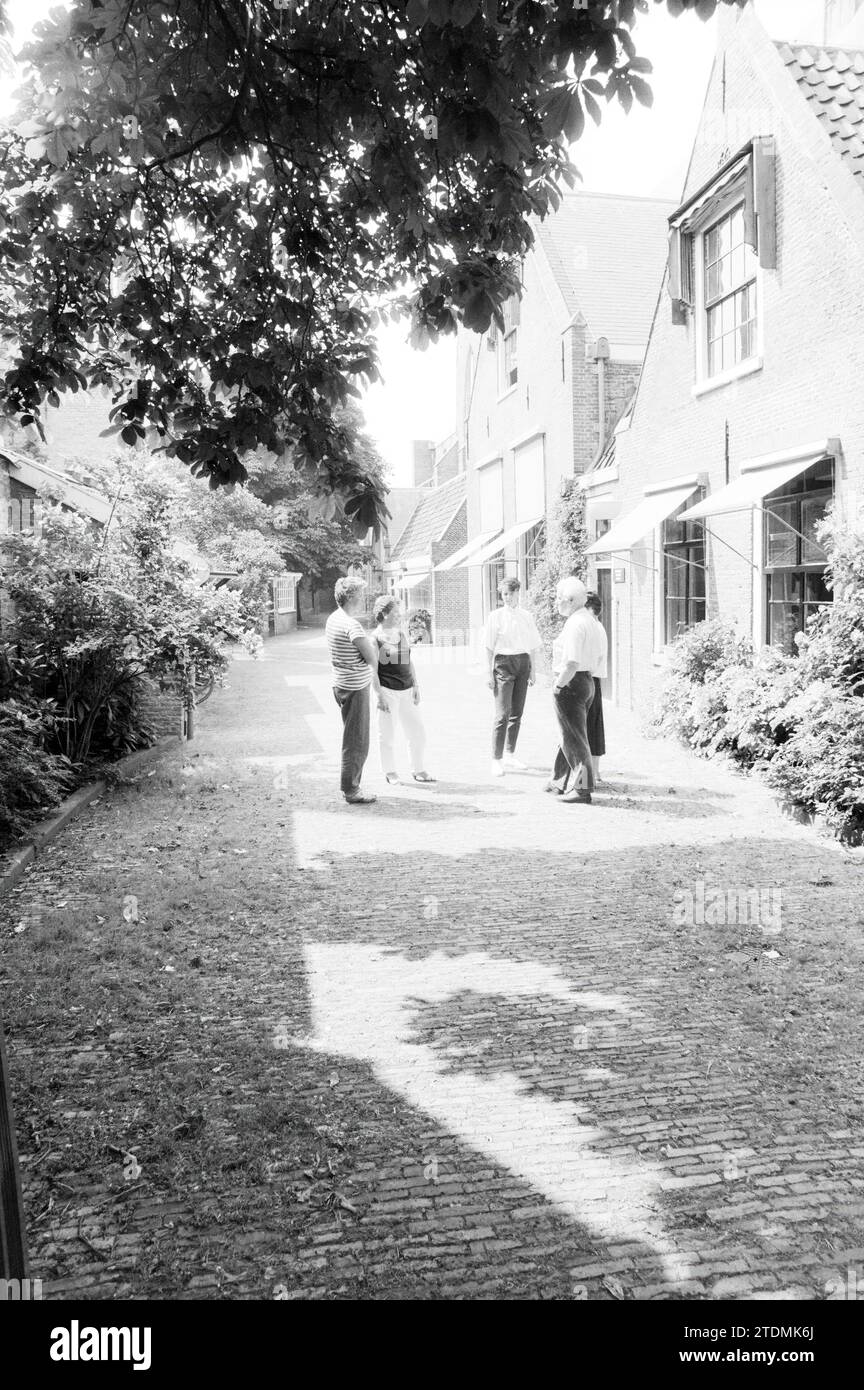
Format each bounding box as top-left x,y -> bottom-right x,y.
486,578 -> 543,777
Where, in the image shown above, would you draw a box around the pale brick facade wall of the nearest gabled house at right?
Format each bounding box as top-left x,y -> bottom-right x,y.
594,2 -> 864,706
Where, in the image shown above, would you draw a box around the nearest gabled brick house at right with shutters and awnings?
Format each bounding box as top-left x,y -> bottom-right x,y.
581,6 -> 864,706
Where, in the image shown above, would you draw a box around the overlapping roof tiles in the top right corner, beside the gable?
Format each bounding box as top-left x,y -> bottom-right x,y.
776,43 -> 864,181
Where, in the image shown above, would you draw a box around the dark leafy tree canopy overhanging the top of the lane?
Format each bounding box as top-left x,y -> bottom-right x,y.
0,0 -> 742,527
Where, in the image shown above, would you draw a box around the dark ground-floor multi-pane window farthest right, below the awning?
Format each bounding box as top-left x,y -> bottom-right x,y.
763,459 -> 833,652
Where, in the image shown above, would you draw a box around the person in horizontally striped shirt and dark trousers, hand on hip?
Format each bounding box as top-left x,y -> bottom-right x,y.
324,578 -> 378,806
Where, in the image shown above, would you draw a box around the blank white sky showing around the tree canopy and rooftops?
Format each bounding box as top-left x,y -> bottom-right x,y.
0,0 -> 824,487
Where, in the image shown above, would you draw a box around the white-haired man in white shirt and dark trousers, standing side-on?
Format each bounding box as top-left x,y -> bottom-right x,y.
549,577 -> 604,803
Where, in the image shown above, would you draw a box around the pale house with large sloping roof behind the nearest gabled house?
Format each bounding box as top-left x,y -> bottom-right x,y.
457,193 -> 672,630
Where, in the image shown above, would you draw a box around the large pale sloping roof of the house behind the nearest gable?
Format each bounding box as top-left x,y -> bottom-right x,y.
538,193 -> 675,360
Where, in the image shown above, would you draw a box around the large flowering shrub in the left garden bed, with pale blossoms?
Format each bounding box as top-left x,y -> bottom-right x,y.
0,489 -> 250,765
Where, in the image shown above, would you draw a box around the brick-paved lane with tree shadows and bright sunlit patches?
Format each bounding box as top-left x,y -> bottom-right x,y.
0,632 -> 864,1300
